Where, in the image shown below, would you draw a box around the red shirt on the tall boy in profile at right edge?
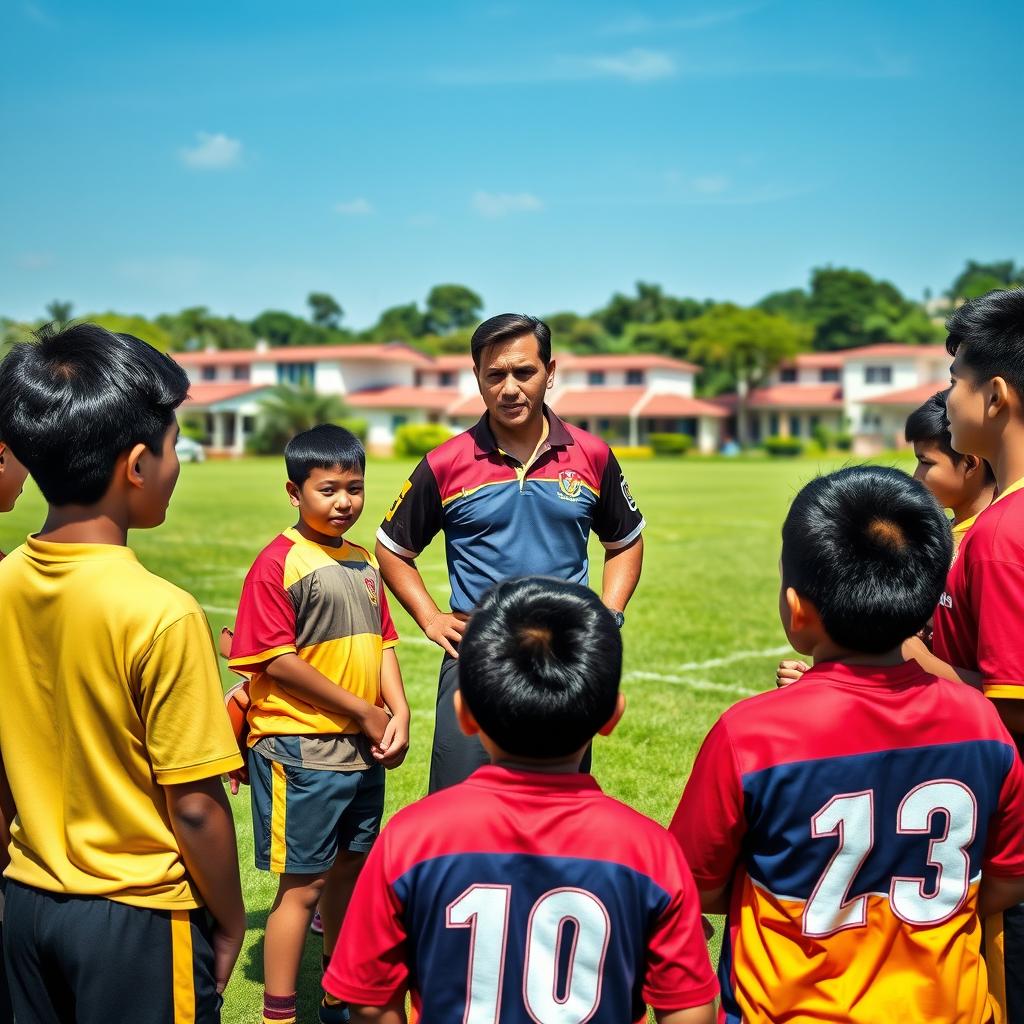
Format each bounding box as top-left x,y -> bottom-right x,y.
933,479 -> 1024,699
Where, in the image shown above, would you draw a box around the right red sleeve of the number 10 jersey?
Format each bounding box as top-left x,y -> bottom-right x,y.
643,848 -> 718,1011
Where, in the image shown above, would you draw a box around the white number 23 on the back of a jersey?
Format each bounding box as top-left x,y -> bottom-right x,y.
803,779 -> 978,938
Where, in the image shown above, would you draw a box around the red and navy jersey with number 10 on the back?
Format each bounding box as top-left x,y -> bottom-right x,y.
324,766 -> 718,1024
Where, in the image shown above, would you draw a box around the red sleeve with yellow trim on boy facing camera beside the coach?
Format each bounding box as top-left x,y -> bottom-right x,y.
227,561 -> 296,672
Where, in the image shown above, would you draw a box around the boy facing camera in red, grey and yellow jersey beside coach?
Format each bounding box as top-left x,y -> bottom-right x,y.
229,425 -> 410,1024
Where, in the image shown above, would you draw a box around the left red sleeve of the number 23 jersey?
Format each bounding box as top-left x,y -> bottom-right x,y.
669,719 -> 746,890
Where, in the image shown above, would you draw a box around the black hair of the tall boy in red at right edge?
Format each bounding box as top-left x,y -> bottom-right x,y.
946,288 -> 1024,398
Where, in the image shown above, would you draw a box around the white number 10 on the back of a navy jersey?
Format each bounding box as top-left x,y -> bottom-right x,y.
445,885 -> 611,1024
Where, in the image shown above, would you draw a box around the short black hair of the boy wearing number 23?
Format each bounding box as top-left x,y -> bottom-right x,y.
782,466 -> 952,654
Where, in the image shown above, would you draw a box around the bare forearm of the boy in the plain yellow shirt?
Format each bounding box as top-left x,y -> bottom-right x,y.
164,777 -> 246,992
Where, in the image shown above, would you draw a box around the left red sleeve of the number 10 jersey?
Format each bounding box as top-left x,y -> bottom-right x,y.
324,828 -> 409,1007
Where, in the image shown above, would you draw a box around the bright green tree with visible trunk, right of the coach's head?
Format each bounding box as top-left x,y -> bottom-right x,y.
683,303 -> 813,443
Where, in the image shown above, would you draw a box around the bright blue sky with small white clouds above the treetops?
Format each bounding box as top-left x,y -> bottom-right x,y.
0,0 -> 1024,327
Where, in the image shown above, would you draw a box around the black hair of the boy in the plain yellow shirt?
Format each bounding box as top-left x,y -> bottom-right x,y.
0,322 -> 188,505
